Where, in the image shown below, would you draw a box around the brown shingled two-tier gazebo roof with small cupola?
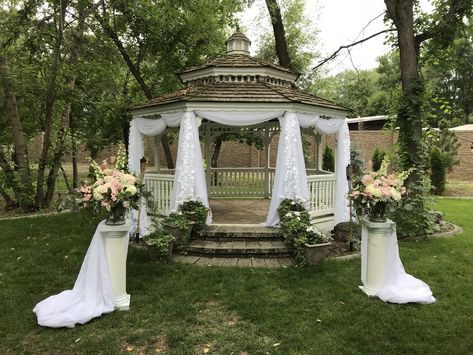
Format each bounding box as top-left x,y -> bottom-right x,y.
130,31 -> 348,116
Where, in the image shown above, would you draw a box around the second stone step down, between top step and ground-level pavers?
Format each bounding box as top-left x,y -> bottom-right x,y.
187,239 -> 291,258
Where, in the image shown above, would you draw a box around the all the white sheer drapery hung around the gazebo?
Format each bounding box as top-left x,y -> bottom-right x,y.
129,110 -> 350,225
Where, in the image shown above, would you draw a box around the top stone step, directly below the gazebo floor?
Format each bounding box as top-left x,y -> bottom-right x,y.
199,224 -> 283,241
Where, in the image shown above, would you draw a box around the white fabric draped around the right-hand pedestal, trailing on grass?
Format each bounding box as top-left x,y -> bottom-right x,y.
361,225 -> 435,303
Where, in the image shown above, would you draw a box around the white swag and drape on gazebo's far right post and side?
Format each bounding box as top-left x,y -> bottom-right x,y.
296,113 -> 350,225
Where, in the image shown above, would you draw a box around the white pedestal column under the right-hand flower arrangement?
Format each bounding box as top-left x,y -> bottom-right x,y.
360,219 -> 396,296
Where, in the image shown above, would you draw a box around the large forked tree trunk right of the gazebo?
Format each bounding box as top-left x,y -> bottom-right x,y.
384,0 -> 471,199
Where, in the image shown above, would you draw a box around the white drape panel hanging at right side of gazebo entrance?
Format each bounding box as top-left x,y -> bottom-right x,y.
265,112 -> 309,226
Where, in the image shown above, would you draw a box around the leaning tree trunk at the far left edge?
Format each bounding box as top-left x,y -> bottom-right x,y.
0,54 -> 35,212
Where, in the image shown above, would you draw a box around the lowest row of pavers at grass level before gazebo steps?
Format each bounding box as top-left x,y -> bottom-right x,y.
173,255 -> 294,269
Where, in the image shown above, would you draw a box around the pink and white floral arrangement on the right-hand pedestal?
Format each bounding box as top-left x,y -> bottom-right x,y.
349,159 -> 411,222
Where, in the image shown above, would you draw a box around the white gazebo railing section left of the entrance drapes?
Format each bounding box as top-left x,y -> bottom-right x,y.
144,173 -> 174,215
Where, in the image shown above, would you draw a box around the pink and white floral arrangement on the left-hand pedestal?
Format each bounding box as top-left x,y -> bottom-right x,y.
80,146 -> 143,224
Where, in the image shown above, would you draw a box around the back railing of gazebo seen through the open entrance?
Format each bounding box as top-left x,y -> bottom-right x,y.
209,168 -> 274,197
